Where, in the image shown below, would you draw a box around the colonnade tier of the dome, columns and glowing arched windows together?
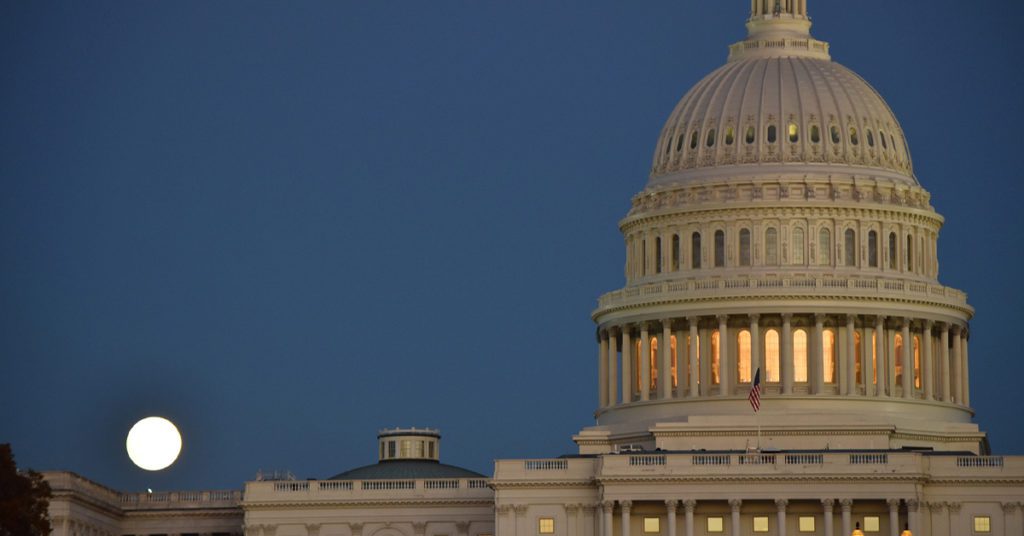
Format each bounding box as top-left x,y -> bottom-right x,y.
598,314 -> 970,408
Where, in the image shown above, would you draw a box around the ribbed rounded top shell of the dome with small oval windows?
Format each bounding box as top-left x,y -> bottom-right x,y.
651,8 -> 916,185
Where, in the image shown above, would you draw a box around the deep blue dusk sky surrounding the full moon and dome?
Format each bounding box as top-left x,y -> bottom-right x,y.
0,0 -> 1024,490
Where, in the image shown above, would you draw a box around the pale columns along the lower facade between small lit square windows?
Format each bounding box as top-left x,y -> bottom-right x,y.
601,499 -> 917,536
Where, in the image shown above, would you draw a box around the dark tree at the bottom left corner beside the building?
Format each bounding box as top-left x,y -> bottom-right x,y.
0,443 -> 52,536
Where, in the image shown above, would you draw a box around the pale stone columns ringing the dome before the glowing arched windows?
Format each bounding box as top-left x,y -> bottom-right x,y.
598,314 -> 970,408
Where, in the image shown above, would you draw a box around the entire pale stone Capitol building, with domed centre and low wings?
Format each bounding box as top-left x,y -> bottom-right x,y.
45,4 -> 1024,536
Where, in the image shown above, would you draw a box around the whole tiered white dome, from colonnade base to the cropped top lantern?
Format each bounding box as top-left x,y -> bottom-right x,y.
577,0 -> 985,453
